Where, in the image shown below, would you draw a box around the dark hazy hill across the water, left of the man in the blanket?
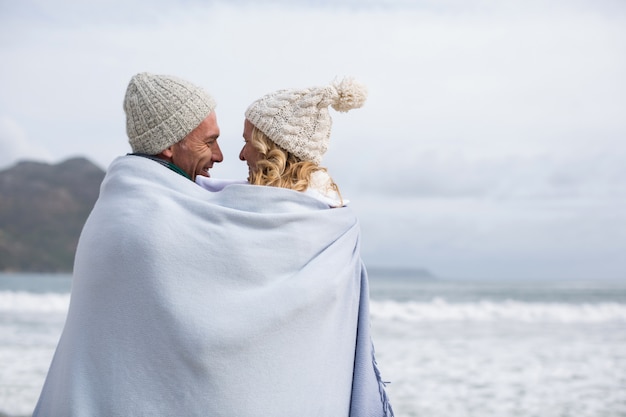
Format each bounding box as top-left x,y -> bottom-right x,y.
0,158 -> 104,272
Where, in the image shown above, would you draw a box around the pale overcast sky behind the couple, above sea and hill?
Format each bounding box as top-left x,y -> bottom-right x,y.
0,0 -> 626,280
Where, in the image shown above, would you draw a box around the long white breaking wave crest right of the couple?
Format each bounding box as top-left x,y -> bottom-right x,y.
370,298 -> 626,323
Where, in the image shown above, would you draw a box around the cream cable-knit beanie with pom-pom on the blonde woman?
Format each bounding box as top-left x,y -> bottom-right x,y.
245,78 -> 367,164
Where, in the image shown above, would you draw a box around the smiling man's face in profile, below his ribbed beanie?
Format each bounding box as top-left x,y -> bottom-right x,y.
170,111 -> 224,181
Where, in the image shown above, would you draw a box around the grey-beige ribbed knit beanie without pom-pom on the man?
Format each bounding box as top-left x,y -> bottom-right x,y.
124,72 -> 215,155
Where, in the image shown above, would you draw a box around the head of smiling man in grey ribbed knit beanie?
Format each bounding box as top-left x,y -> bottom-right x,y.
124,72 -> 223,181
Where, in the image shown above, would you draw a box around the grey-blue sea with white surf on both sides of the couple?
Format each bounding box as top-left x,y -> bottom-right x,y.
0,270 -> 626,417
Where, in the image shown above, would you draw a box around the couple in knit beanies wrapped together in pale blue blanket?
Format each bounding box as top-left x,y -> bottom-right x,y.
34,73 -> 393,417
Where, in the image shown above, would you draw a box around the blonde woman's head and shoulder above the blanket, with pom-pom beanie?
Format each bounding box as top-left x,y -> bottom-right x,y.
239,79 -> 367,207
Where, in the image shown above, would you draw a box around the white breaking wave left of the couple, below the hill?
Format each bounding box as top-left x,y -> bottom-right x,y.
0,291 -> 70,314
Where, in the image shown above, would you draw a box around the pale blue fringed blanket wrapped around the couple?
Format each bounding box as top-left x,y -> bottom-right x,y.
34,156 -> 392,417
